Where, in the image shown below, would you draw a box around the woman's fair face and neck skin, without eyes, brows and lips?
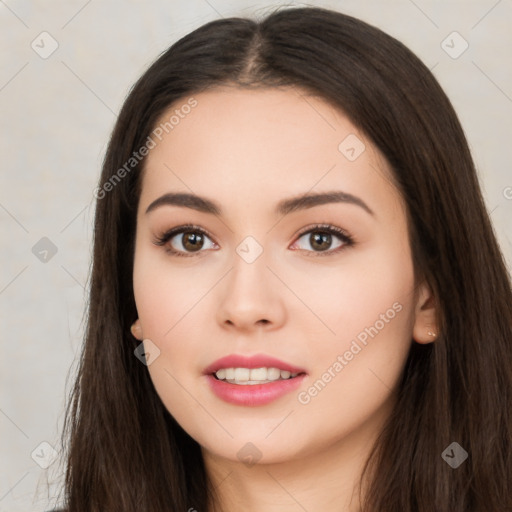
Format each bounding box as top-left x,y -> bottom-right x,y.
132,87 -> 436,512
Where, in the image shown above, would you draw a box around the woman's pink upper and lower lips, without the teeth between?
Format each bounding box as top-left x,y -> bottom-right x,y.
203,354 -> 306,406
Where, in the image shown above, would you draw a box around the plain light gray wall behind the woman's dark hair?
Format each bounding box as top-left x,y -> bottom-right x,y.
0,0 -> 512,512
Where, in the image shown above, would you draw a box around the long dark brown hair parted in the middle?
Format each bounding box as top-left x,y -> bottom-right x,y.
63,8 -> 512,512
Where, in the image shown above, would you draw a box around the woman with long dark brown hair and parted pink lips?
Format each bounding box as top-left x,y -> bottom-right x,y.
58,8 -> 512,512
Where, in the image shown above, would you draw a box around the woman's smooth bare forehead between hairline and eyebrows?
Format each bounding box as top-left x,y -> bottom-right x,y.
141,87 -> 397,217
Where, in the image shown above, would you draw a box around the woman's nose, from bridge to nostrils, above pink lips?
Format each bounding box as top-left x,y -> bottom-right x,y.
217,247 -> 286,332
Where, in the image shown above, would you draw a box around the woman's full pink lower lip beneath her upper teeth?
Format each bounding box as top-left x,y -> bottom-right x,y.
206,374 -> 306,406
